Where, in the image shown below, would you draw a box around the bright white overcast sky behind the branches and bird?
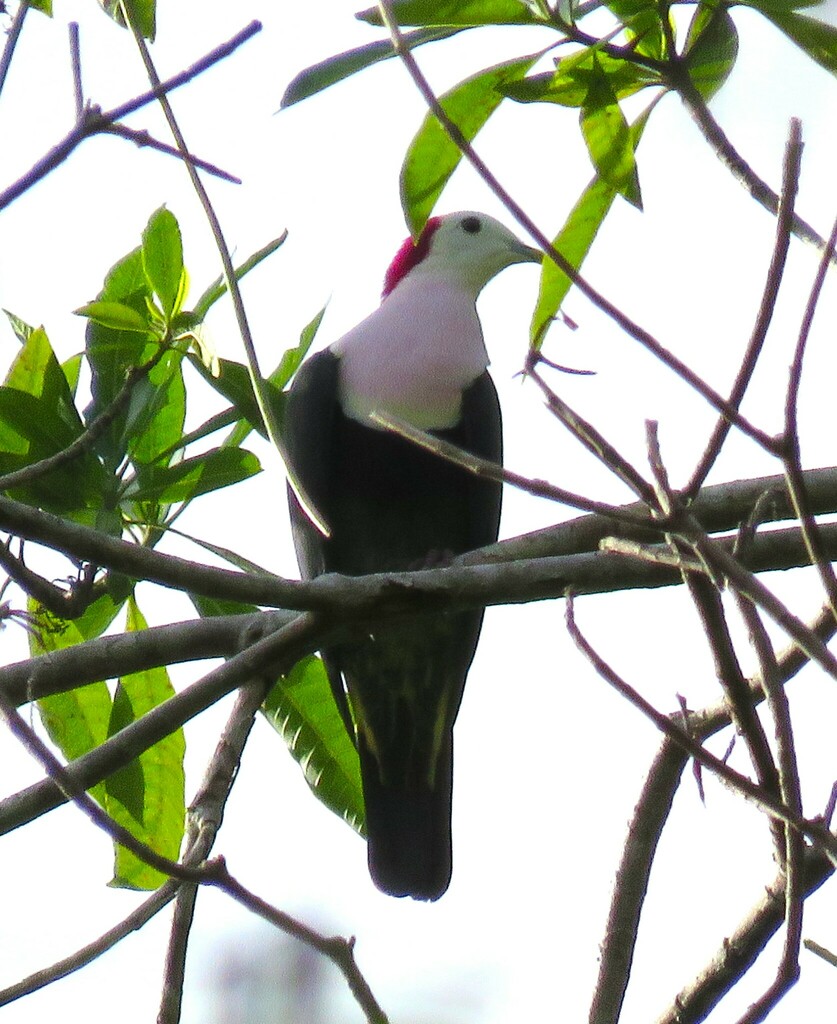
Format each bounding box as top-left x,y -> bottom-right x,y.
0,0 -> 837,1024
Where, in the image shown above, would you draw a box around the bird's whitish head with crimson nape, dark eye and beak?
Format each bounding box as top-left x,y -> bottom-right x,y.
383,210 -> 543,299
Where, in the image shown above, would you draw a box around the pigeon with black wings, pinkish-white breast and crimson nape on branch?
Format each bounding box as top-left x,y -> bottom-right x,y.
283,211 -> 542,901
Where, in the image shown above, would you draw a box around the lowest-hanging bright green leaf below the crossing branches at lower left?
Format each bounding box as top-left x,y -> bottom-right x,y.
104,598 -> 185,889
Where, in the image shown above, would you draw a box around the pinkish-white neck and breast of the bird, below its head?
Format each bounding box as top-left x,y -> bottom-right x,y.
333,276 -> 489,430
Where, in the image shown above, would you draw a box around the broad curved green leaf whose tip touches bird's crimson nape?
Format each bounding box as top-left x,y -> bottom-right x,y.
401,53 -> 541,236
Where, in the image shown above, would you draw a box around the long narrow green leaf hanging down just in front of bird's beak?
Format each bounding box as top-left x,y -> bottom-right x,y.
530,100 -> 656,349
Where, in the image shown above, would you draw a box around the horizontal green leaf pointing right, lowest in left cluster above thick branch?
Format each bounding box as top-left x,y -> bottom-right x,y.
126,447 -> 261,505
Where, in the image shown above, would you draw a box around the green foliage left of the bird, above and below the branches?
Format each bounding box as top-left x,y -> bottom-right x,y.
0,208 -> 363,889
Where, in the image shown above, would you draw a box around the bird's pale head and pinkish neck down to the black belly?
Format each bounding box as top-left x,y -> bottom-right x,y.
332,210 -> 542,429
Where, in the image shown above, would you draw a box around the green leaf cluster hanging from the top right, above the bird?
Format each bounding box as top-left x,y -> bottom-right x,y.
283,0 -> 837,345
